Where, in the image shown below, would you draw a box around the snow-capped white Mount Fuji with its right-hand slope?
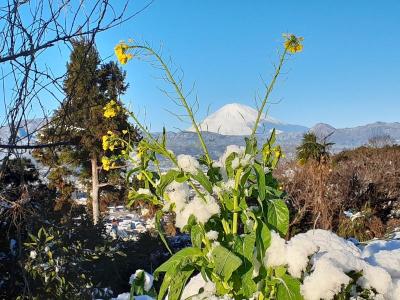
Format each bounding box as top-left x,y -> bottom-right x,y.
188,103 -> 308,135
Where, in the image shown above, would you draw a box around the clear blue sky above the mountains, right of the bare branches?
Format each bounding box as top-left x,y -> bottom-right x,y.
23,0 -> 400,130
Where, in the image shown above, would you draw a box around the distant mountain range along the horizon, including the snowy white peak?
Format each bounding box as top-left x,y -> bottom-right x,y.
0,107 -> 400,162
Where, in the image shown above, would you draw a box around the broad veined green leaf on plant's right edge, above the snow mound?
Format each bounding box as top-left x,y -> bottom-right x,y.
267,199 -> 289,235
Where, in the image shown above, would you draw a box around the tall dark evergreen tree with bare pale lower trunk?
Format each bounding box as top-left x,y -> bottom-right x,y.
35,39 -> 139,224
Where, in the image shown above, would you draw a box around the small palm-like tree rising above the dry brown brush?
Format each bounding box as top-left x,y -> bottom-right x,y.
296,132 -> 334,164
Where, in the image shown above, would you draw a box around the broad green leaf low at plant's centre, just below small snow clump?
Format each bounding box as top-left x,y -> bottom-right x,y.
211,246 -> 242,281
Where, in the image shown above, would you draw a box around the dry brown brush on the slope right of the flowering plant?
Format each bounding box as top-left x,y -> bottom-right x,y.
276,146 -> 400,239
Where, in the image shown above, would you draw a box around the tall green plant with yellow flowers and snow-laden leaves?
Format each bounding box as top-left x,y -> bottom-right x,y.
103,34 -> 303,300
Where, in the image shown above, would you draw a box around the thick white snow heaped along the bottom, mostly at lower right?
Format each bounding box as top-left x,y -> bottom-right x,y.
114,229 -> 400,300
